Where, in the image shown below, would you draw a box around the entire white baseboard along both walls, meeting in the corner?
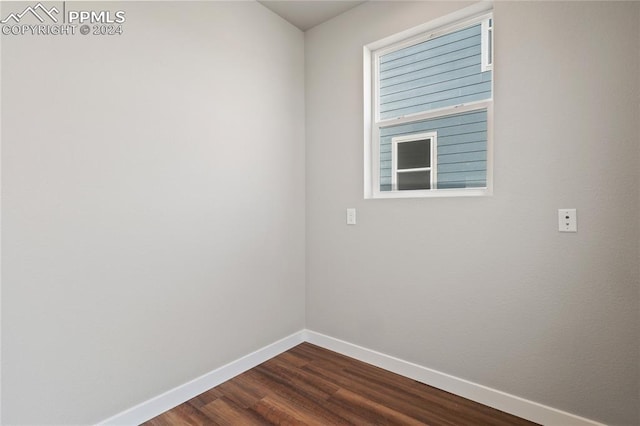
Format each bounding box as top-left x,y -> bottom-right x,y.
99,330 -> 604,426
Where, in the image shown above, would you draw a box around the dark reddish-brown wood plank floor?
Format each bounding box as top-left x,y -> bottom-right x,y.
145,343 -> 535,426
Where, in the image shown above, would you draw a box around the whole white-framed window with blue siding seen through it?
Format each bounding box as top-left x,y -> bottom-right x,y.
365,5 -> 494,198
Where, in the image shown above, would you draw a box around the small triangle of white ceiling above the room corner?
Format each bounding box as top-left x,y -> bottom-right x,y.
258,0 -> 364,31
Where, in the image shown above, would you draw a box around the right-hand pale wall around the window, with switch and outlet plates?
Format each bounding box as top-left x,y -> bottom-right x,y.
305,2 -> 640,424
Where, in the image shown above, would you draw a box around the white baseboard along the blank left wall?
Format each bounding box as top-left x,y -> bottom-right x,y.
99,330 -> 306,426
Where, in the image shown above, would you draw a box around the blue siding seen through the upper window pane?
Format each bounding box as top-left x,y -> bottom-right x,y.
379,24 -> 492,119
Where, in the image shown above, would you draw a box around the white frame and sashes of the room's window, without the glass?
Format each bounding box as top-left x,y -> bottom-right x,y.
363,2 -> 494,199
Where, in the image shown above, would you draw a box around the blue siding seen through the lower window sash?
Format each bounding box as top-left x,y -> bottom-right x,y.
380,109 -> 487,191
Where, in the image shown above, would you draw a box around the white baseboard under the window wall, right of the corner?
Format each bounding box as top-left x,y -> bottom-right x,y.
305,330 -> 604,426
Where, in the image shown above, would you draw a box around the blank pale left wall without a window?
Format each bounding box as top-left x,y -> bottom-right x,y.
2,2 -> 305,424
